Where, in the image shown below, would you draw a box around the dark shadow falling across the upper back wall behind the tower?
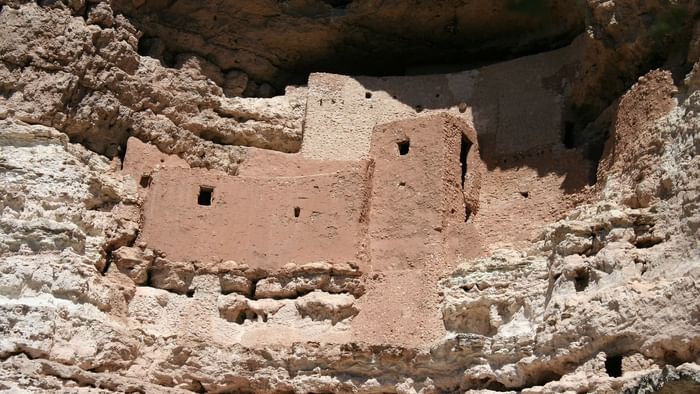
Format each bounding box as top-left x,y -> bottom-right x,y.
357,71 -> 607,193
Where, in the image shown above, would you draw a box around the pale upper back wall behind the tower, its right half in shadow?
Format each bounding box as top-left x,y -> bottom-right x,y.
301,40 -> 582,160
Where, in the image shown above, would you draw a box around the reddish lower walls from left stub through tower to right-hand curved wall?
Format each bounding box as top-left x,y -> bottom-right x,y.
134,105 -> 587,271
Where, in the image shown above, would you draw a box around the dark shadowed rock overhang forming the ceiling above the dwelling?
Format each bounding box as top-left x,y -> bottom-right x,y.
112,0 -> 585,86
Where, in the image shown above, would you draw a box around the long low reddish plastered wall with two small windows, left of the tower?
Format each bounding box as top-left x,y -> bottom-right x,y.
140,161 -> 371,270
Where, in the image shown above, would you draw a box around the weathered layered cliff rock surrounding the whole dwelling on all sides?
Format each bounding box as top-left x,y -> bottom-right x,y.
0,0 -> 700,394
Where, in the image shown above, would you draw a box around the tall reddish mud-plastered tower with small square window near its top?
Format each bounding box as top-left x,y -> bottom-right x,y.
369,114 -> 478,271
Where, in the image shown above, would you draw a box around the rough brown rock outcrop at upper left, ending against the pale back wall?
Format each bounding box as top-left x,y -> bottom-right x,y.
0,3 -> 304,172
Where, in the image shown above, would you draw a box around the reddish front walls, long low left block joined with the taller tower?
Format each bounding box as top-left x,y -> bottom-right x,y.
135,113 -> 481,271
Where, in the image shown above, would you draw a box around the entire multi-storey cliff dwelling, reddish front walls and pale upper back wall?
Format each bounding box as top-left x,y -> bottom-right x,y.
124,47 -> 591,272
